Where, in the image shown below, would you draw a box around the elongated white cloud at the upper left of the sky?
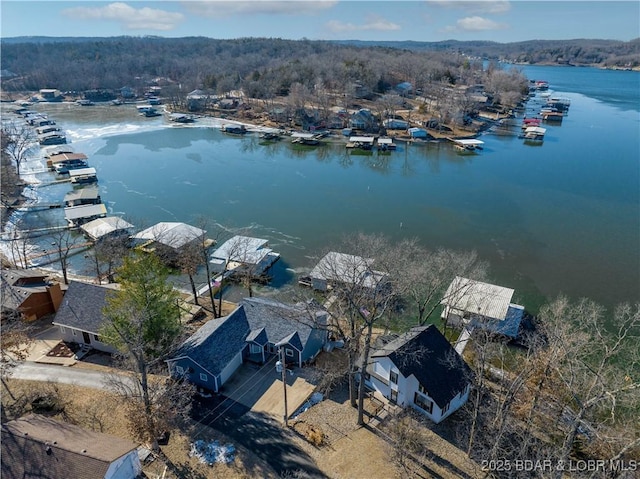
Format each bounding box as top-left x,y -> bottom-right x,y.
63,2 -> 184,31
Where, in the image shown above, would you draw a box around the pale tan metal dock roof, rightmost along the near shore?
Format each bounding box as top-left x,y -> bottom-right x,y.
442,276 -> 514,319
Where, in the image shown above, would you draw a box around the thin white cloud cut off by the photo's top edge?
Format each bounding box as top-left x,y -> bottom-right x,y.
183,0 -> 338,17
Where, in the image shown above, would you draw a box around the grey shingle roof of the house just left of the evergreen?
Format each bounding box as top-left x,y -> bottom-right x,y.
53,281 -> 113,334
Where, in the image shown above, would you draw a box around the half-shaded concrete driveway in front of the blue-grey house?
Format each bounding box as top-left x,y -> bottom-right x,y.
220,357 -> 315,421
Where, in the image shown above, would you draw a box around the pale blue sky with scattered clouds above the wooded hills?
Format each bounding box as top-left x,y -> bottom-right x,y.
0,0 -> 640,43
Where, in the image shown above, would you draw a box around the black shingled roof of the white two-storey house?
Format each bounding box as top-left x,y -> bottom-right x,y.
371,324 -> 473,409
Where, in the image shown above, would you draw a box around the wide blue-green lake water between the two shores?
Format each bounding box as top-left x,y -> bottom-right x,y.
5,67 -> 640,311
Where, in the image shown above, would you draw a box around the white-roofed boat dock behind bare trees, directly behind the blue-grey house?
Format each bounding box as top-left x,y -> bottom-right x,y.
301,251 -> 388,291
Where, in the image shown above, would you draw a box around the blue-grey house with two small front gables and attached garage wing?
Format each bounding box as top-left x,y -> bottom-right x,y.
167,298 -> 327,392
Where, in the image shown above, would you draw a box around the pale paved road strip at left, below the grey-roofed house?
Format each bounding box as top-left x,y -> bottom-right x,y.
5,362 -> 135,389
